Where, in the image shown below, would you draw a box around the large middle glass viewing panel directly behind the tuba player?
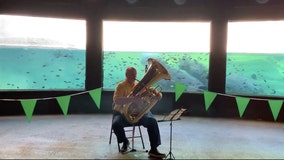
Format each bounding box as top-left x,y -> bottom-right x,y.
103,21 -> 210,92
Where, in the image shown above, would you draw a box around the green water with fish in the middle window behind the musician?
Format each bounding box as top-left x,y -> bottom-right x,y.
103,52 -> 209,92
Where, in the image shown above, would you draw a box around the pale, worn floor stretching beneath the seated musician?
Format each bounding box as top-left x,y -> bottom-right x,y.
0,114 -> 284,159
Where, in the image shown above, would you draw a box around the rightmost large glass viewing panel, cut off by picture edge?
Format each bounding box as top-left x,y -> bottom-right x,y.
226,21 -> 284,97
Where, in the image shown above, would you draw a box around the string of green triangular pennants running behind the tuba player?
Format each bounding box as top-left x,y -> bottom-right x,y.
0,82 -> 283,122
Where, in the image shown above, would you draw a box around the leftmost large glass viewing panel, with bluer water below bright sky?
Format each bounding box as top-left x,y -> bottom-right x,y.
0,15 -> 86,91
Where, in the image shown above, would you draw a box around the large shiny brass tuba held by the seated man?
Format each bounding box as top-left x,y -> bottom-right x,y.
123,58 -> 171,124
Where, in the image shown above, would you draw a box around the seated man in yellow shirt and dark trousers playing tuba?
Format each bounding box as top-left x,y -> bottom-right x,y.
112,67 -> 165,158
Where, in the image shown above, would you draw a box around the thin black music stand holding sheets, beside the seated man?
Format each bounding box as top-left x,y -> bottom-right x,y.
158,107 -> 186,159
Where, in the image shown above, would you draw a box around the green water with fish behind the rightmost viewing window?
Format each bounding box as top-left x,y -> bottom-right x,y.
226,53 -> 284,97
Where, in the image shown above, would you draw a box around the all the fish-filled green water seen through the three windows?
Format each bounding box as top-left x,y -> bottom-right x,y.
0,47 -> 284,97
